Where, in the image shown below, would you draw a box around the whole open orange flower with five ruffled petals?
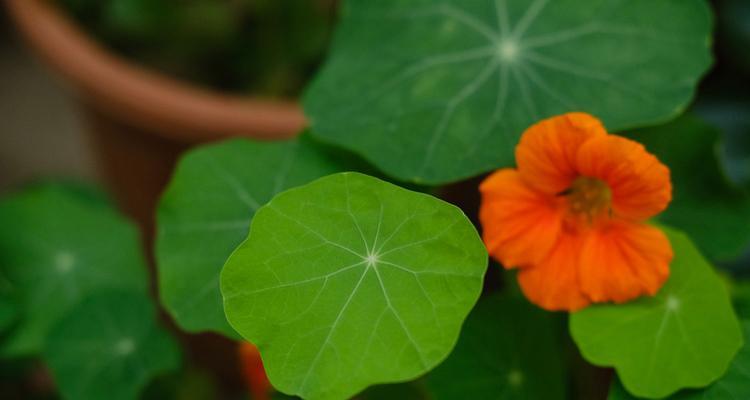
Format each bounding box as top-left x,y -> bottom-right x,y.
479,113 -> 672,311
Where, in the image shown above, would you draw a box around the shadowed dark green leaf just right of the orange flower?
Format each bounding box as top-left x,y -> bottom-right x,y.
628,116 -> 750,261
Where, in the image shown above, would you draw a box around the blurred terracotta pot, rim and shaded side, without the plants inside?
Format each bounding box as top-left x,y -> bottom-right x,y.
5,0 -> 305,234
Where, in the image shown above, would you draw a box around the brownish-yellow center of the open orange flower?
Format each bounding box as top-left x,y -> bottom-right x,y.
563,176 -> 612,222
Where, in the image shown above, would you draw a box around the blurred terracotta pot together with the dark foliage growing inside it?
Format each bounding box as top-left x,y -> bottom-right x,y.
6,0 -> 333,232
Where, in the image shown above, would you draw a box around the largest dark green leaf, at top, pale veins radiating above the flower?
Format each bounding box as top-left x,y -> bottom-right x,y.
304,0 -> 712,183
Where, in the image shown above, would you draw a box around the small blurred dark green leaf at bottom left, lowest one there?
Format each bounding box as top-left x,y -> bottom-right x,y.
44,291 -> 180,400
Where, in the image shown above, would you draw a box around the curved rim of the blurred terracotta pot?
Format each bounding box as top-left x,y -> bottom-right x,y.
5,0 -> 306,143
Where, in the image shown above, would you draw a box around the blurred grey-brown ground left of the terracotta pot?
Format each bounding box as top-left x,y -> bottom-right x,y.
0,7 -> 97,191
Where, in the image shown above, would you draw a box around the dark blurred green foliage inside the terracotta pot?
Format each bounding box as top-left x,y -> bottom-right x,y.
60,0 -> 336,97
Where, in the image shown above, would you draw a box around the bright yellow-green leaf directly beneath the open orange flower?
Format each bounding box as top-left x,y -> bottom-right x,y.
570,230 -> 742,398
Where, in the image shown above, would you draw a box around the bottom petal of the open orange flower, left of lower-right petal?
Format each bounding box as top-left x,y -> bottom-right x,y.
518,233 -> 589,311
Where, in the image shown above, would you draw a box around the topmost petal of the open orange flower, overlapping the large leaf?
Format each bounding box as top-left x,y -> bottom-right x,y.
516,113 -> 607,194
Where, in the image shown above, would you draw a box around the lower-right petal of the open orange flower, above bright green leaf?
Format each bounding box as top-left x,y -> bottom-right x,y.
578,221 -> 673,303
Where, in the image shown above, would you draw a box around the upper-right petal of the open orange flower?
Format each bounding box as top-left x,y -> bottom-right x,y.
577,135 -> 672,221
